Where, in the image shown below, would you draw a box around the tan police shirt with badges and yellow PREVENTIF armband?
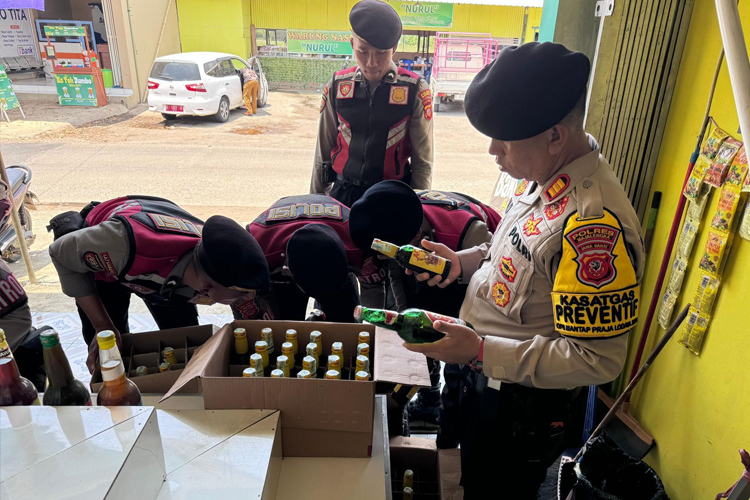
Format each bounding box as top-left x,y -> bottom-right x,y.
459,139 -> 644,389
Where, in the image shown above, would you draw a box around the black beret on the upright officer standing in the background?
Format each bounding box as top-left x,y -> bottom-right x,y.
349,0 -> 401,50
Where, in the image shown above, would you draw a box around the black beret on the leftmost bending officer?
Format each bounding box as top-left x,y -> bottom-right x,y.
195,215 -> 271,291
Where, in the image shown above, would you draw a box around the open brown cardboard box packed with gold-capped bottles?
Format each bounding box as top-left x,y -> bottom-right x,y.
162,321 -> 430,457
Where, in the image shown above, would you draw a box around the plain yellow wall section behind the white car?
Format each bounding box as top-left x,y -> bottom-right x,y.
177,0 -> 251,57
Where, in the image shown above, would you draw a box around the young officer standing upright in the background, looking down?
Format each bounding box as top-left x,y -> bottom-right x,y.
310,0 -> 433,207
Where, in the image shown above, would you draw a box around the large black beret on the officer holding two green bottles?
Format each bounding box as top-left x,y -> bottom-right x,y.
464,42 -> 591,141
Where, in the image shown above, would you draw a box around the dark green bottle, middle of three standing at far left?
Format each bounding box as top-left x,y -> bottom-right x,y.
41,330 -> 92,406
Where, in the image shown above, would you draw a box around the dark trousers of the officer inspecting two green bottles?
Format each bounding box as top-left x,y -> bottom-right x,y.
460,373 -> 577,500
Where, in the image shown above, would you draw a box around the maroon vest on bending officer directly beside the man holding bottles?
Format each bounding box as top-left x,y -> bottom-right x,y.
417,191 -> 501,252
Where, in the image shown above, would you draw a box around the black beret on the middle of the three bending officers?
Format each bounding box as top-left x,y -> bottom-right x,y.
286,223 -> 349,298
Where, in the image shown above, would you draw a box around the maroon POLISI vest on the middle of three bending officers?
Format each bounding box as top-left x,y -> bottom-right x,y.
247,194 -> 382,283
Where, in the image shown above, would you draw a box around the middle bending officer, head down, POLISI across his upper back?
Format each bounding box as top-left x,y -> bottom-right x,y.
247,194 -> 386,323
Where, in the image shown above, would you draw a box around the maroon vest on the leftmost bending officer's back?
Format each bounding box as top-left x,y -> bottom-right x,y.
86,196 -> 203,294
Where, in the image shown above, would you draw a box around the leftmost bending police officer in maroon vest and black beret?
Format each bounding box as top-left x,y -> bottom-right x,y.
49,196 -> 272,370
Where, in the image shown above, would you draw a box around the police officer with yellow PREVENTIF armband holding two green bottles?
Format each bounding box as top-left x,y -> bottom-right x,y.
407,43 -> 644,500
